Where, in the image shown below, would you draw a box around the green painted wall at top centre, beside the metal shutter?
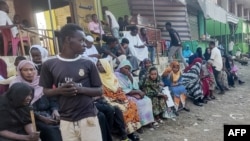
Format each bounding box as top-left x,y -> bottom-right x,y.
101,0 -> 130,19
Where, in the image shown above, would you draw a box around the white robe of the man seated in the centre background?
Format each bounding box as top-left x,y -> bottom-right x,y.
124,32 -> 148,61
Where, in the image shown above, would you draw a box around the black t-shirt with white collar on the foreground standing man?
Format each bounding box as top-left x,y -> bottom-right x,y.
40,56 -> 102,121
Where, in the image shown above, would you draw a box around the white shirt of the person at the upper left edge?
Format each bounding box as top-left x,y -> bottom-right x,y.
0,10 -> 18,37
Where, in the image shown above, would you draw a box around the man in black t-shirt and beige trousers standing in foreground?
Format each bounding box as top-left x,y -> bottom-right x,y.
40,24 -> 102,141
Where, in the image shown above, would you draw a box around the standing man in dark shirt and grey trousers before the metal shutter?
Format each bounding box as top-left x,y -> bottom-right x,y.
165,22 -> 187,66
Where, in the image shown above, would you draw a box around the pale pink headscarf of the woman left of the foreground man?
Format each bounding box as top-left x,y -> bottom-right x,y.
9,60 -> 43,104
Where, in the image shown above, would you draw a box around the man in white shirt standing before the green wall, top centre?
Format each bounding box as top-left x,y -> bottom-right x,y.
102,6 -> 120,39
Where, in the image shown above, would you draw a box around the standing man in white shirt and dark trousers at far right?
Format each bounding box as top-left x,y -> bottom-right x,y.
209,41 -> 225,94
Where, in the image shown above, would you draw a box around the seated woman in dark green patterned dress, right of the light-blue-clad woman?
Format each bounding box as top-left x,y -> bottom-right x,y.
139,67 -> 168,123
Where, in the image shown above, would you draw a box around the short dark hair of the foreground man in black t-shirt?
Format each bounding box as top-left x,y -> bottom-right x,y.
60,23 -> 83,42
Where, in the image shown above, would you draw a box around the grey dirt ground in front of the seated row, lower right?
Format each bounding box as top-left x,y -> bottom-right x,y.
140,60 -> 250,141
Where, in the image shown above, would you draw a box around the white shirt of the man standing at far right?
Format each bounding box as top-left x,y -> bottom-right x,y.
210,47 -> 223,71
